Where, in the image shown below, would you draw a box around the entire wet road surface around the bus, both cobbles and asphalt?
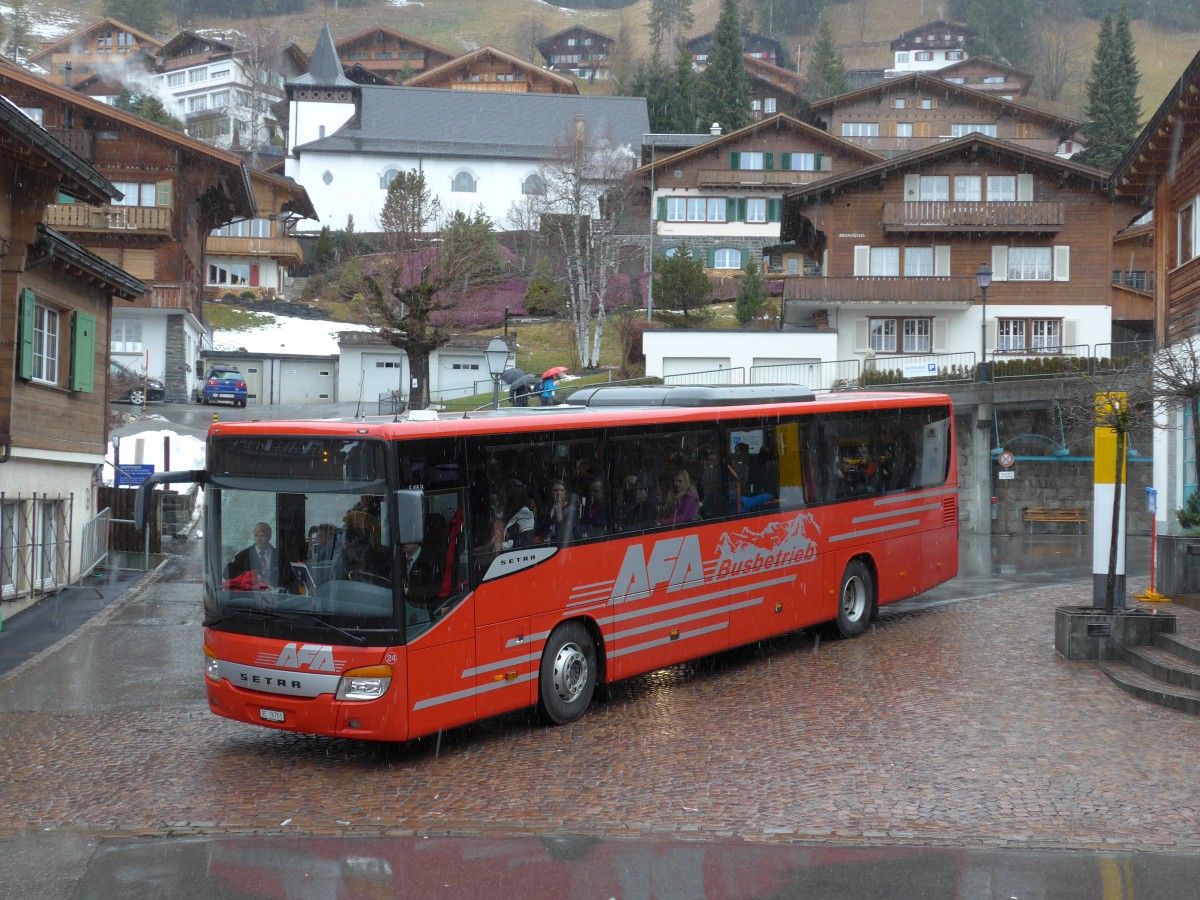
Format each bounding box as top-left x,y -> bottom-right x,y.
0,407 -> 1200,900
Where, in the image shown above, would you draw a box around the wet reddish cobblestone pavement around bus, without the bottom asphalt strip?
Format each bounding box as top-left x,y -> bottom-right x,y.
0,542 -> 1200,853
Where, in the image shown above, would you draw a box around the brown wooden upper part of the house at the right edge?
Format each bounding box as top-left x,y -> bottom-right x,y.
1112,54 -> 1200,347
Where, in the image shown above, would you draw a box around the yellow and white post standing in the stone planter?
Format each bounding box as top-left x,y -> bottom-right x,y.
1092,391 -> 1128,610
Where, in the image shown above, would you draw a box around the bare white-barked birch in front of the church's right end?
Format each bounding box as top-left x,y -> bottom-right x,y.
523,116 -> 636,368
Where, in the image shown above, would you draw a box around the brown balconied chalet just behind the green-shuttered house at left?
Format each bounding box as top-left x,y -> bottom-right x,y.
0,62 -> 256,400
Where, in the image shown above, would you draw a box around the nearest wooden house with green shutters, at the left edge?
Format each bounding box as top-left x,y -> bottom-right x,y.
0,97 -> 146,617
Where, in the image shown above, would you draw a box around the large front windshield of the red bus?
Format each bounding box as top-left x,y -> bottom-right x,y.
204,436 -> 402,646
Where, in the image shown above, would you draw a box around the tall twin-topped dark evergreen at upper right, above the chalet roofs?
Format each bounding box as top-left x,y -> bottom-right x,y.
1081,16 -> 1140,169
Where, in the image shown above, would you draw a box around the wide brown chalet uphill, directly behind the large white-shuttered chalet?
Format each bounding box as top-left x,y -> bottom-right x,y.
810,72 -> 1082,156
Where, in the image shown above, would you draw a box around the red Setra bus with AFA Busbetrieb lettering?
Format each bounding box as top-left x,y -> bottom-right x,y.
138,385 -> 958,740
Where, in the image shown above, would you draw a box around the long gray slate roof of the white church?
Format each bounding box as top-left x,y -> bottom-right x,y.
299,85 -> 650,160
